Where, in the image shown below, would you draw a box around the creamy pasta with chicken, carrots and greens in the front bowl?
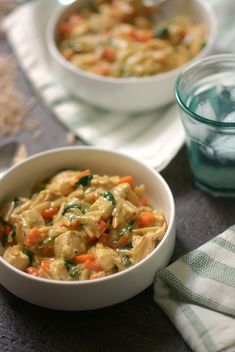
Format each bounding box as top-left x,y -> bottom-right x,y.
0,170 -> 167,280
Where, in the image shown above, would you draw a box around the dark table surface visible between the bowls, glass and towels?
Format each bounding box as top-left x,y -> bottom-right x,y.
0,8 -> 235,352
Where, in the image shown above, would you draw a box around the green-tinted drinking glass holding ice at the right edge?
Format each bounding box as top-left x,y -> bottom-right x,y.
175,54 -> 235,197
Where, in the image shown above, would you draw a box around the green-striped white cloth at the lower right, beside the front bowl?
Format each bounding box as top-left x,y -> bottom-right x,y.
154,226 -> 235,352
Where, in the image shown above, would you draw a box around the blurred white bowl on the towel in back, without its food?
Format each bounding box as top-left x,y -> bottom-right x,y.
47,0 -> 217,112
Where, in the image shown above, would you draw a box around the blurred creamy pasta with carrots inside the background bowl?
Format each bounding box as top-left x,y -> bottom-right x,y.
58,0 -> 206,77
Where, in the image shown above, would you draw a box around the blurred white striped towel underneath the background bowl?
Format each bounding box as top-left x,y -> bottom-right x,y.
4,0 -> 235,171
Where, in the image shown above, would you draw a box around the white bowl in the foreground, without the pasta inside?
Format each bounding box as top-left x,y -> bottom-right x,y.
0,147 -> 175,310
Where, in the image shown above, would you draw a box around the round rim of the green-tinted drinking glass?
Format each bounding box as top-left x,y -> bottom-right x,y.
175,54 -> 235,128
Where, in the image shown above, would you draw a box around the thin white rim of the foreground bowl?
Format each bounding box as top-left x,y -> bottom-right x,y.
0,146 -> 175,286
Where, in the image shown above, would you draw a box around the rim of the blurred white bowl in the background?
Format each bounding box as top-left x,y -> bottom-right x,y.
46,0 -> 218,85
